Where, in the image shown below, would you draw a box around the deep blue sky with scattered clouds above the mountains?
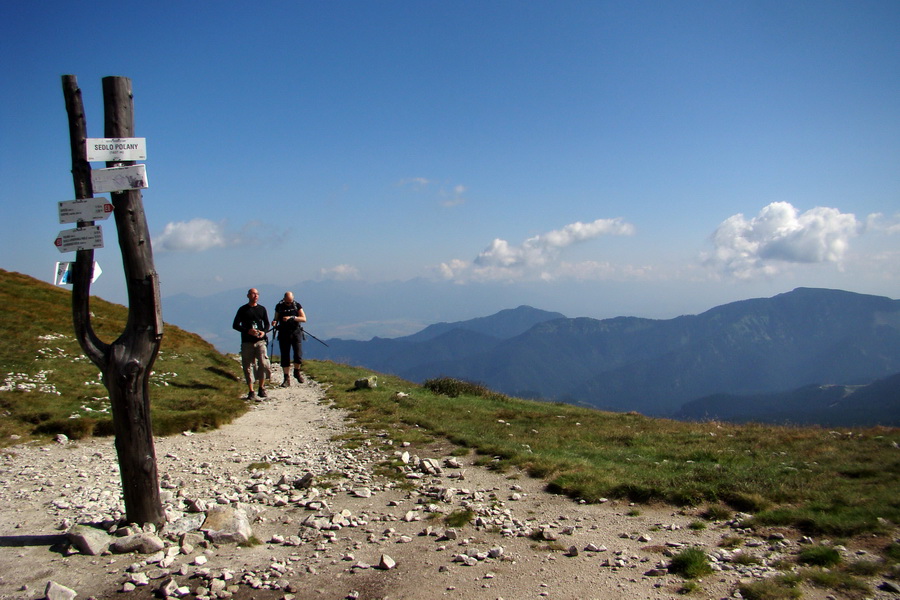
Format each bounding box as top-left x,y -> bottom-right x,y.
0,0 -> 900,336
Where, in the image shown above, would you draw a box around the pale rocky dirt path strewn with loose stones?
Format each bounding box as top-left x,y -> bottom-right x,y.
0,383 -> 896,600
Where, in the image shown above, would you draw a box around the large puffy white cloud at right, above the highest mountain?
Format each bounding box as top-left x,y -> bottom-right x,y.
704,202 -> 865,279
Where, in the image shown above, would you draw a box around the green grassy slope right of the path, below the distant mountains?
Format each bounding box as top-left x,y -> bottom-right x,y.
307,361 -> 900,537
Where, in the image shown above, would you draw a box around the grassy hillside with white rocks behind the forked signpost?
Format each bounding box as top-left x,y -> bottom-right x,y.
0,269 -> 247,445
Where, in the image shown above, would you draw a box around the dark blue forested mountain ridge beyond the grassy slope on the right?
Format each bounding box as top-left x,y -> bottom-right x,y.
307,288 -> 900,416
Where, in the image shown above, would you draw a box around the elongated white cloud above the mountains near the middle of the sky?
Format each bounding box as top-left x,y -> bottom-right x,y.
438,219 -> 635,281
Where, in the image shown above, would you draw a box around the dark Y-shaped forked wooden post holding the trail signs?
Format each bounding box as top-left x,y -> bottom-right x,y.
63,75 -> 165,525
